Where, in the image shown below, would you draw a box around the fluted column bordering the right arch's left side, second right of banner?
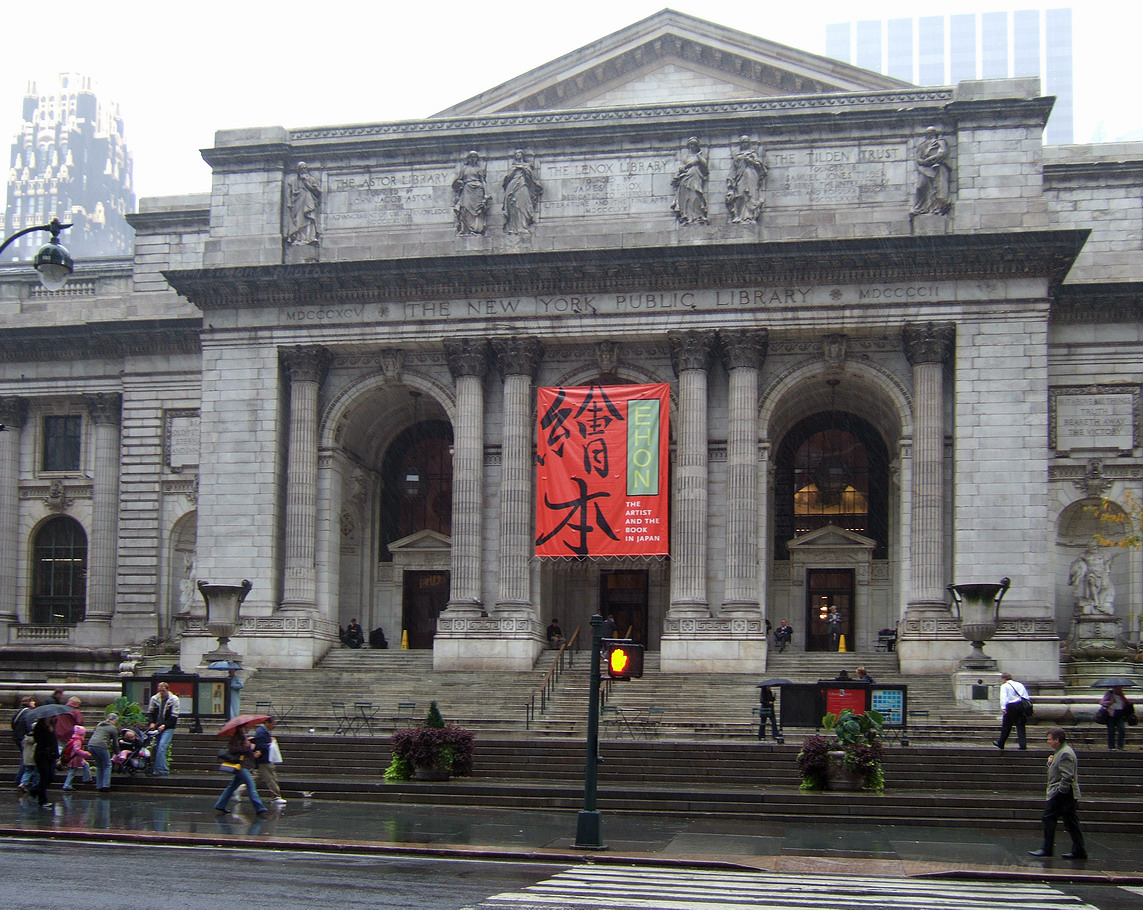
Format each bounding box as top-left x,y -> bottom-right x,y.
719,329 -> 767,615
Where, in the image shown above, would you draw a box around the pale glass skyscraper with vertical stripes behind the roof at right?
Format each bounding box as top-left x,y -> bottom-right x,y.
825,9 -> 1074,145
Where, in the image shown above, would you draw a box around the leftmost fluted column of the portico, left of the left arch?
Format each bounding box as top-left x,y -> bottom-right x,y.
281,348 -> 329,610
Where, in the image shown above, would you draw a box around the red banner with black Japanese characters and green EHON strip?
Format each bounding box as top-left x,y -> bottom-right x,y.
536,383 -> 670,557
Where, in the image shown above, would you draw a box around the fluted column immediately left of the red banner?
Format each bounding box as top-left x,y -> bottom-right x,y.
493,338 -> 544,616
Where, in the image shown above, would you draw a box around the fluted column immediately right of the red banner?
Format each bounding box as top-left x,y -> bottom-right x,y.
668,332 -> 714,618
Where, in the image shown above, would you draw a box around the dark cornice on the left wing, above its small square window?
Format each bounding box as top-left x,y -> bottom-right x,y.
0,319 -> 202,362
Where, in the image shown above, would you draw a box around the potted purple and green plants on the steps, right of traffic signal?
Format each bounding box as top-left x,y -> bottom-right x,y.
798,708 -> 885,791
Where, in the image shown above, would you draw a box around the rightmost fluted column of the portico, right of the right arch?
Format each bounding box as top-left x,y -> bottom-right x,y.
903,322 -> 956,612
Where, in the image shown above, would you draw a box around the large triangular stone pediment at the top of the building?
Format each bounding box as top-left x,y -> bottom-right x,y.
437,9 -> 909,117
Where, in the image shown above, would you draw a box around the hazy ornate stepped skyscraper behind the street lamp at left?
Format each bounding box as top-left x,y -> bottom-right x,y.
3,73 -> 135,262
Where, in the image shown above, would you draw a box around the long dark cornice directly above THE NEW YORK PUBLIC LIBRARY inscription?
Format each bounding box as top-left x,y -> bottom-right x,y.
163,230 -> 1088,311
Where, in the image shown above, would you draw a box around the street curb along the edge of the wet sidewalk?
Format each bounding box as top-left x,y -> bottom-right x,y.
0,825 -> 1143,886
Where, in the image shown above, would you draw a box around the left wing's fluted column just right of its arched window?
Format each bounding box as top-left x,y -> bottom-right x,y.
83,392 -> 122,622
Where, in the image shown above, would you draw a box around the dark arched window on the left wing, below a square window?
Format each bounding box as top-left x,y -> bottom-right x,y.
32,516 -> 87,625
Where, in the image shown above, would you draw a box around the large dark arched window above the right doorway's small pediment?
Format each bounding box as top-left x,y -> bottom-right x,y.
774,412 -> 889,559
